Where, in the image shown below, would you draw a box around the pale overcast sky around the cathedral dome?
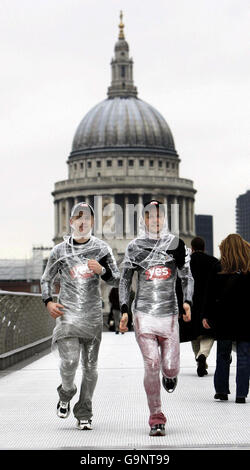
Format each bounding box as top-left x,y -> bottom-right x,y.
0,0 -> 250,258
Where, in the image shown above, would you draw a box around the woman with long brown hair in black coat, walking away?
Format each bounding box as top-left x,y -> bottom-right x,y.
203,234 -> 250,403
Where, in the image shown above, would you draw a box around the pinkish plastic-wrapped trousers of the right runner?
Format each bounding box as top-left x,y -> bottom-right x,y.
134,315 -> 180,426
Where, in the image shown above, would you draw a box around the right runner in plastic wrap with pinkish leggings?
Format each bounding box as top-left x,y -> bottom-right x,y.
119,201 -> 193,436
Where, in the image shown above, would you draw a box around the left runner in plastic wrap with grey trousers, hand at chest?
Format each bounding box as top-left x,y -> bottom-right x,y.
41,202 -> 120,430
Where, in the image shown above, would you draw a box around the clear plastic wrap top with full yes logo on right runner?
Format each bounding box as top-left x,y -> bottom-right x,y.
119,234 -> 193,334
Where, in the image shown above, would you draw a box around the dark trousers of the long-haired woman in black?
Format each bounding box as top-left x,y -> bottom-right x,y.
214,340 -> 250,397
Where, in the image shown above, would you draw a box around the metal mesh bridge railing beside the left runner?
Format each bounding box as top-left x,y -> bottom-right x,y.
0,291 -> 55,370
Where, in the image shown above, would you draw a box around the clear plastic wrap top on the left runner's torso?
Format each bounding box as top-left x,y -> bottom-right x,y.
41,236 -> 120,343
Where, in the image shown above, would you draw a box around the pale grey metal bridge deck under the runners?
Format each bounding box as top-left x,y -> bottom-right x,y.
0,332 -> 250,450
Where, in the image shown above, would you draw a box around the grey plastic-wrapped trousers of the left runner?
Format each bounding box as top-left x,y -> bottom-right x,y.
57,337 -> 101,419
